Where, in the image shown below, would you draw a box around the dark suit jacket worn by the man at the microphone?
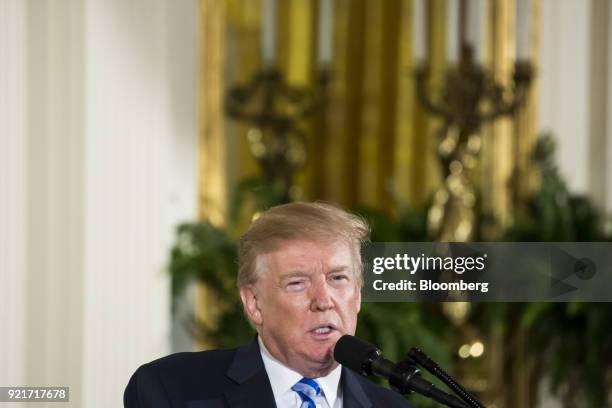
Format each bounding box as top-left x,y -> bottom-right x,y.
123,340 -> 413,408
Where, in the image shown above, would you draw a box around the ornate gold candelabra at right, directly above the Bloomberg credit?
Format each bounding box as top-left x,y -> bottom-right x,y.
416,44 -> 533,241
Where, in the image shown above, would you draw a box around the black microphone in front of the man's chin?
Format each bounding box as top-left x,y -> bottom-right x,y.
334,335 -> 466,408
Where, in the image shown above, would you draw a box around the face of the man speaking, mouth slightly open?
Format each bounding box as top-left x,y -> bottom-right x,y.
240,240 -> 361,378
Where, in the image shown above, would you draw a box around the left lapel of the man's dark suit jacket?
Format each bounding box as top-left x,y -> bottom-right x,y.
225,339 -> 276,408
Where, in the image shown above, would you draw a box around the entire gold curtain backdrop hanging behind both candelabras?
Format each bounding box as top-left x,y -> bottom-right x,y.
199,0 -> 538,225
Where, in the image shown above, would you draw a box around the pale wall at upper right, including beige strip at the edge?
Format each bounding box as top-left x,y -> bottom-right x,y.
538,0 -> 612,217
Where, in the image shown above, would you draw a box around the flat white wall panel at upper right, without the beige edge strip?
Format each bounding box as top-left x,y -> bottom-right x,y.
537,0 -> 590,193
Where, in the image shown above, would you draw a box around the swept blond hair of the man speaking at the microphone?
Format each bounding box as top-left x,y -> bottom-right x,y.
237,202 -> 370,288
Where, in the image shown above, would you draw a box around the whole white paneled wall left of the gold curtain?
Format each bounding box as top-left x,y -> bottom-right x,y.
0,0 -> 197,408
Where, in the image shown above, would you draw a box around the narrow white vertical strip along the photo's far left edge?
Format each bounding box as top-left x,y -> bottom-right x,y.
0,0 -> 28,386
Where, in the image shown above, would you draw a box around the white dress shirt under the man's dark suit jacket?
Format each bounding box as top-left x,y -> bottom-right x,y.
257,336 -> 342,408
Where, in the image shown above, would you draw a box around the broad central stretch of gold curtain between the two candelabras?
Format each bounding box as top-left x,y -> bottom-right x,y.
305,0 -> 445,211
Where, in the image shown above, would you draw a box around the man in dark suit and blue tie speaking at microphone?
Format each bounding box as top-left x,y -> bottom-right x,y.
124,203 -> 412,408
